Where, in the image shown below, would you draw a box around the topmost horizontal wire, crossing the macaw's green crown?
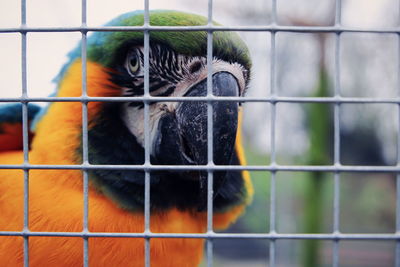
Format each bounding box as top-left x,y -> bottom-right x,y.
0,25 -> 400,34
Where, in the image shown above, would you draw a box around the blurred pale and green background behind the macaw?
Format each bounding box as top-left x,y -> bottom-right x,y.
0,0 -> 400,266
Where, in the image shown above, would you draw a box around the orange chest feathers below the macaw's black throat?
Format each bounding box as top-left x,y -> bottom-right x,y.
0,153 -> 205,266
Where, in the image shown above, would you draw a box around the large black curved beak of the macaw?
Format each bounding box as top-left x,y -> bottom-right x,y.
153,72 -> 239,209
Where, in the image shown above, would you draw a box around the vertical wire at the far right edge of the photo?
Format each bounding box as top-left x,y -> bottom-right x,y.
395,1 -> 400,267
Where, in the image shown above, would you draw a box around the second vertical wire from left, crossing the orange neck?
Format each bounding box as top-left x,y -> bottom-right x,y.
81,0 -> 89,267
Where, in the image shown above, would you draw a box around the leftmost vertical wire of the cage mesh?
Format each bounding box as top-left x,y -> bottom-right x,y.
21,0 -> 29,267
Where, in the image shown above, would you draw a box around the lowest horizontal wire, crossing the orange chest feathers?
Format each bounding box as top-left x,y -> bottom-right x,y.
0,231 -> 400,240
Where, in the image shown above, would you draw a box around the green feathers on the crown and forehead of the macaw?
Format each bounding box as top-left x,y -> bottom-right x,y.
85,10 -> 251,70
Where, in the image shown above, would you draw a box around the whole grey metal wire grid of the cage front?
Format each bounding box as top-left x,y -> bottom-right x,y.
0,0 -> 400,267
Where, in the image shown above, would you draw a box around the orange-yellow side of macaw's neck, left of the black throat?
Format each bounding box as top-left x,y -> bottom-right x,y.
29,60 -> 119,186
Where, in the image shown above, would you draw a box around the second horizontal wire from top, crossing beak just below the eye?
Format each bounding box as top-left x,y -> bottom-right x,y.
0,96 -> 400,104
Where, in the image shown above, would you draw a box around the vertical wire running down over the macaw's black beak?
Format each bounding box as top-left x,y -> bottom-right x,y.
207,0 -> 214,267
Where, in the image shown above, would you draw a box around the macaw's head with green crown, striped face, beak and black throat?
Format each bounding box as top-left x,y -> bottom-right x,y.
58,11 -> 251,213
